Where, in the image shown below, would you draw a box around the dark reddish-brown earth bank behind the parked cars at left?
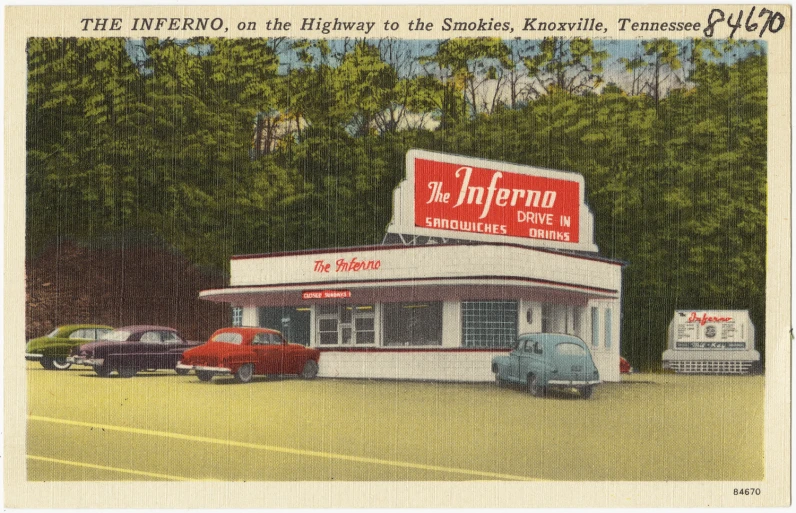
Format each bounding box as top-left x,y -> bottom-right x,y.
25,242 -> 230,340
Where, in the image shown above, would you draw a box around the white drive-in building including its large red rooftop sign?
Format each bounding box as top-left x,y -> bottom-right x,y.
200,150 -> 623,381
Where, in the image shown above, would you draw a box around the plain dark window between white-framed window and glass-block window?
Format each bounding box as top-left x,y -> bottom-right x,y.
384,301 -> 442,346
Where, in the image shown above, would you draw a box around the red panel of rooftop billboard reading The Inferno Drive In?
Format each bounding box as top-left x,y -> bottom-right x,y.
414,158 -> 580,243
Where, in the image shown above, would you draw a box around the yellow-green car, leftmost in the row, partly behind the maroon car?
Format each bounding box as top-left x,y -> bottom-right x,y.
25,324 -> 113,370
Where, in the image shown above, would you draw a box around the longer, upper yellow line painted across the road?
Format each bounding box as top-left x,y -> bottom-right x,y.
28,415 -> 537,481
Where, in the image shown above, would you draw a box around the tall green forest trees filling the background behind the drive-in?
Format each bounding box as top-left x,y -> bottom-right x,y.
25,38 -> 768,369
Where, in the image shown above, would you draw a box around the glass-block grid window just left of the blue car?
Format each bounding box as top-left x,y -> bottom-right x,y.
462,301 -> 517,348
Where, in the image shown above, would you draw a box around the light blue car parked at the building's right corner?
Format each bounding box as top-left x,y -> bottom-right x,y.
492,333 -> 600,399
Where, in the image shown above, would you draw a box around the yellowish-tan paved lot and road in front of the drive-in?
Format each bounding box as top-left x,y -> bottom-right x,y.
27,363 -> 764,481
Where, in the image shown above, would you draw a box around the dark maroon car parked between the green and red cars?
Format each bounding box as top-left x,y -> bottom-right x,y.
66,326 -> 199,378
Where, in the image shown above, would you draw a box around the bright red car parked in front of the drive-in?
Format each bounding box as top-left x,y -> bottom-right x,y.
176,328 -> 321,383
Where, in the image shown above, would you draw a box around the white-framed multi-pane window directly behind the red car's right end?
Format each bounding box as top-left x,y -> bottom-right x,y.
316,305 -> 376,346
